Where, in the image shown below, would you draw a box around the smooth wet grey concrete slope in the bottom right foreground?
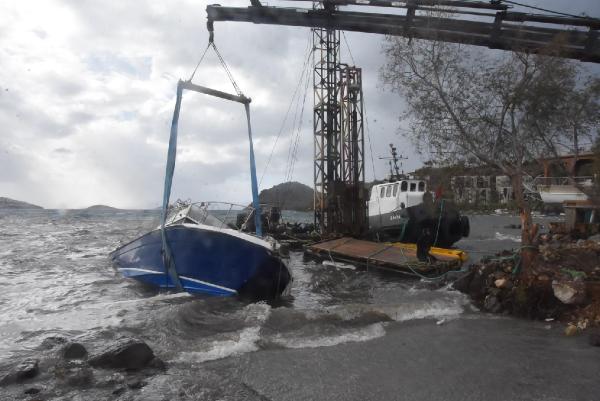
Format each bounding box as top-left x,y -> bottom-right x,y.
233,317 -> 600,401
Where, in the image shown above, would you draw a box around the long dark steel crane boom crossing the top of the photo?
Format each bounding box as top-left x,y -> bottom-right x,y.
206,0 -> 600,63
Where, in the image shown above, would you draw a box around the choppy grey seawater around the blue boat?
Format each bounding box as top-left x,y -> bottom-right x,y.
0,210 -> 560,365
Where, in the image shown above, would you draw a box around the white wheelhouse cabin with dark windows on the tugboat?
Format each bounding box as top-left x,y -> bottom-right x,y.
369,179 -> 427,216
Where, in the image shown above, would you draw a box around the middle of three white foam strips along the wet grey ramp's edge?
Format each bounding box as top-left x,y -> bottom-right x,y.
271,323 -> 385,348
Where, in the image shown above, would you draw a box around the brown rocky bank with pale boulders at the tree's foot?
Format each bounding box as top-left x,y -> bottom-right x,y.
453,234 -> 600,345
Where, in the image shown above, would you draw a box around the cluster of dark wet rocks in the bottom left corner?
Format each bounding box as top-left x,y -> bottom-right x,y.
0,337 -> 167,400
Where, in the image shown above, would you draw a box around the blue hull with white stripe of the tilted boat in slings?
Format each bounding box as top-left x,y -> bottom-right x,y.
111,224 -> 291,299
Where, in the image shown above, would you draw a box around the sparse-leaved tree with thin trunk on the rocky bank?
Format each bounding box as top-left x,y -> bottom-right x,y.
381,37 -> 598,271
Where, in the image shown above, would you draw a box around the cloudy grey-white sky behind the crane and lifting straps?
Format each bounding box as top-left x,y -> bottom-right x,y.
0,0 -> 600,208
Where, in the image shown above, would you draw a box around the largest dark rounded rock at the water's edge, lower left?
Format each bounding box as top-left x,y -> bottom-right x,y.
89,338 -> 154,369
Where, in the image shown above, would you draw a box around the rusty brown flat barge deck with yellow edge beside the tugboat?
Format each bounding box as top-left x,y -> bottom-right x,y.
305,237 -> 467,276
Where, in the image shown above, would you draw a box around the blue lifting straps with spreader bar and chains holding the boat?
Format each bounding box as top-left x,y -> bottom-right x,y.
160,41 -> 262,291
